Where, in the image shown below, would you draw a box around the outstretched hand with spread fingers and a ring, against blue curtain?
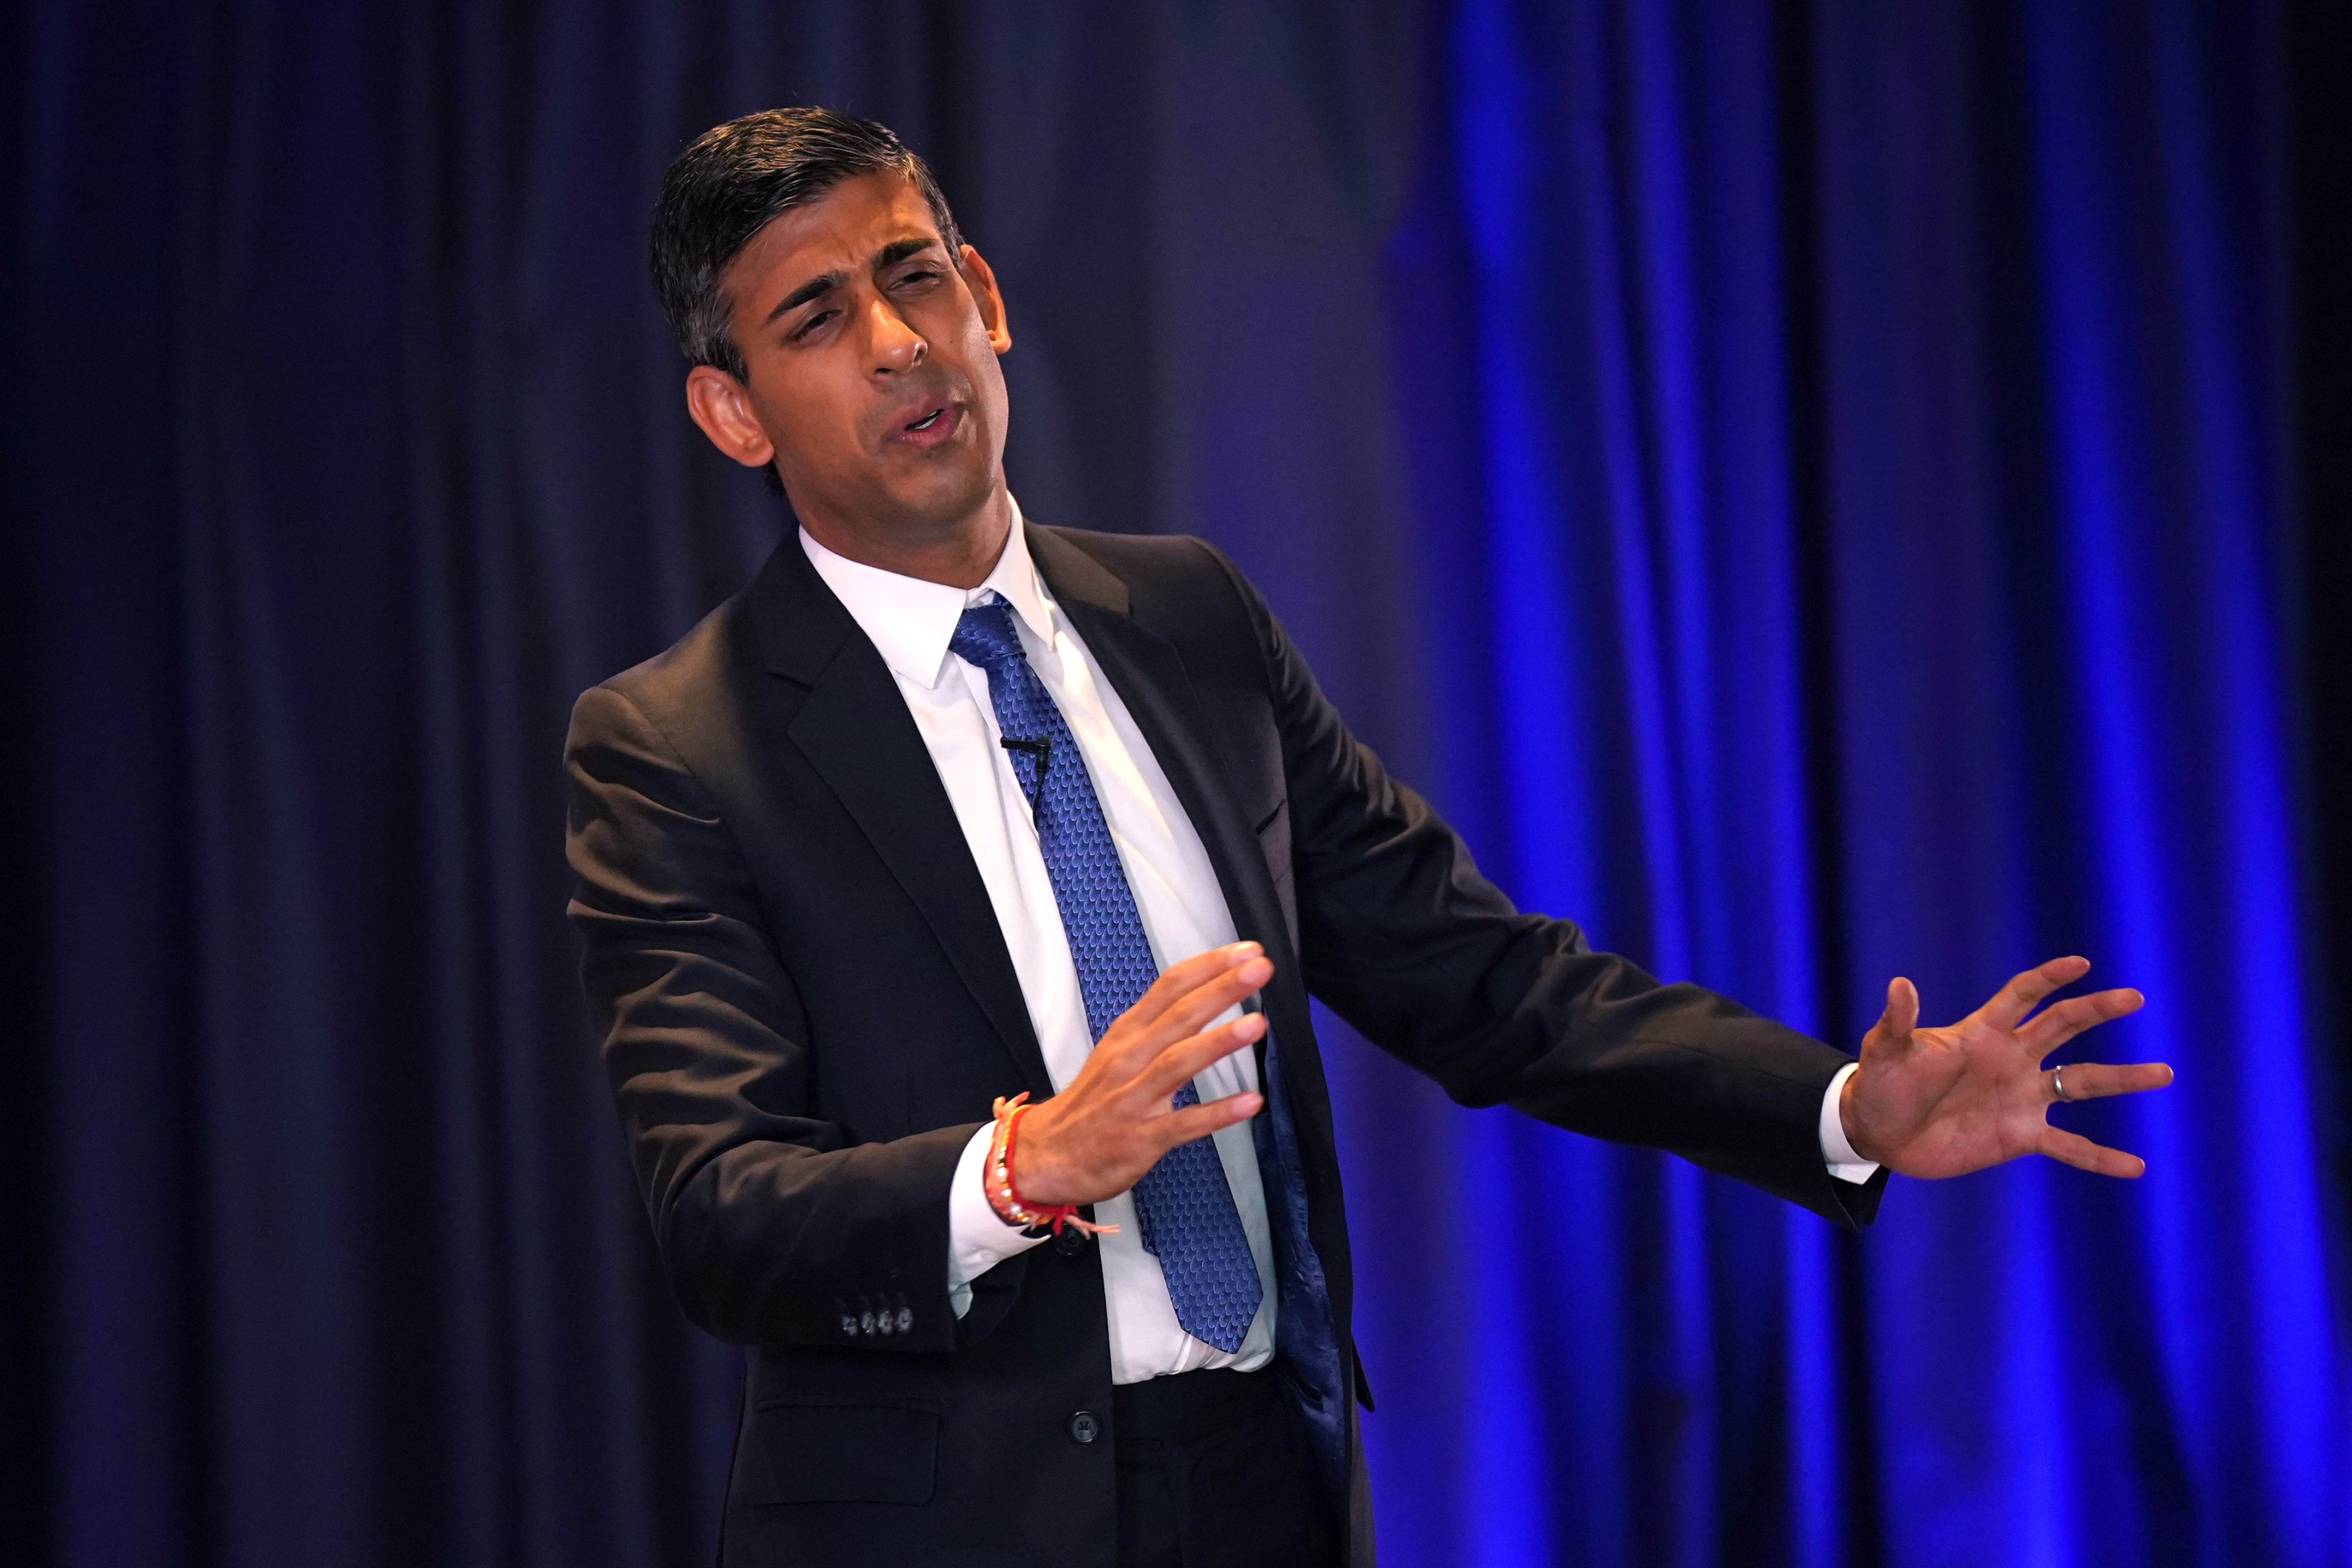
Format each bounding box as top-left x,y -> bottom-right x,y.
1839,959 -> 2173,1178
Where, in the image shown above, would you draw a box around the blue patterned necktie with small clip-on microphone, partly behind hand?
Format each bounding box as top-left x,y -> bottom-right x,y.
948,602 -> 1261,1352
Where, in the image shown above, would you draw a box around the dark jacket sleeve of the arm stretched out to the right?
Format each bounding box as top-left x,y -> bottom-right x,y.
1218,545 -> 1886,1225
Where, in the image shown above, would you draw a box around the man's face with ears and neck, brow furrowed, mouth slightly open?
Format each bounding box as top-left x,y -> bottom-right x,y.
687,174 -> 1011,543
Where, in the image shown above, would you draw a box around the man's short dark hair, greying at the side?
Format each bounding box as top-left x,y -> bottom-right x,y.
652,108 -> 964,381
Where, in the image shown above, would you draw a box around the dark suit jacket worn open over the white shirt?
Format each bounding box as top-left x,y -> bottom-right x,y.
567,526 -> 1879,1568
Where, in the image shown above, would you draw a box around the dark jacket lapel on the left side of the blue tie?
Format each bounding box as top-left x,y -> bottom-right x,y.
750,538 -> 1054,1100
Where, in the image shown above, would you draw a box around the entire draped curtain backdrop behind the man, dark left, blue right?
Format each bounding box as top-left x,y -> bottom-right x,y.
0,0 -> 2352,1568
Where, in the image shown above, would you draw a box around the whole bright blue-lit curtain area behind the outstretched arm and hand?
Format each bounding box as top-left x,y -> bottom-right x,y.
1343,0 -> 2352,1566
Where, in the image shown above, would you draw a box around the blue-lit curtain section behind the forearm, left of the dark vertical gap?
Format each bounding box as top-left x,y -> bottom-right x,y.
1343,5 -> 1853,1563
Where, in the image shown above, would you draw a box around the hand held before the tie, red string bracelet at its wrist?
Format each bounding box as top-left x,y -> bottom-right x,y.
1014,943 -> 1275,1203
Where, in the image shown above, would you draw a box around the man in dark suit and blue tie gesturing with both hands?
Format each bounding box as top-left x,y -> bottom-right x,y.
569,111 -> 2171,1566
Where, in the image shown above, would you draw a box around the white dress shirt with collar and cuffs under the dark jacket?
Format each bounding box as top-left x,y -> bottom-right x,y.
800,505 -> 1877,1382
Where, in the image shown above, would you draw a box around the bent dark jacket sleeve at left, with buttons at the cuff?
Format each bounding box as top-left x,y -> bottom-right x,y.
564,686 -> 976,1349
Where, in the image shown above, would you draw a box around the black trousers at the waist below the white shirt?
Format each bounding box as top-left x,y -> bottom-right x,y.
1112,1370 -> 1338,1568
